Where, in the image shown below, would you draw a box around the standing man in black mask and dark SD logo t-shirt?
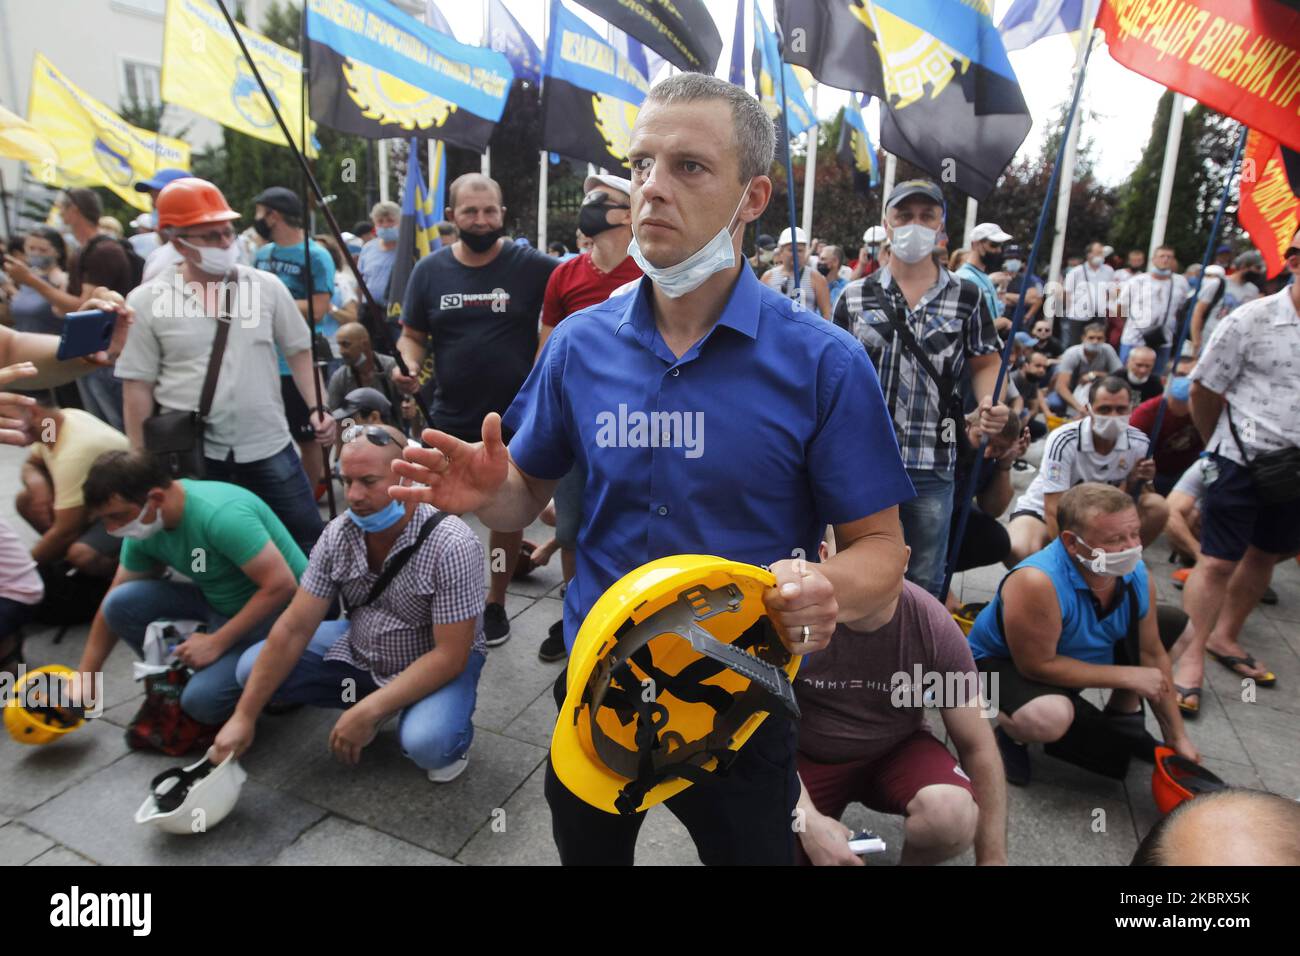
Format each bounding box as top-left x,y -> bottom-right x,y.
391,173 -> 559,646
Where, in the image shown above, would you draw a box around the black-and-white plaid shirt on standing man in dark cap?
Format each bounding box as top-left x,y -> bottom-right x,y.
835,267 -> 1002,472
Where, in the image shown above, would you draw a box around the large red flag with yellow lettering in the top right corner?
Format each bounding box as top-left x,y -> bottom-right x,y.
1097,0 -> 1300,150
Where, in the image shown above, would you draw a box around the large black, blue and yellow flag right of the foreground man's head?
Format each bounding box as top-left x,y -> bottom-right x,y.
777,0 -> 1031,200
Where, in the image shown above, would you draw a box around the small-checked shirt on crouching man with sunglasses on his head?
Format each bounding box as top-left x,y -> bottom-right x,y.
300,505 -> 488,687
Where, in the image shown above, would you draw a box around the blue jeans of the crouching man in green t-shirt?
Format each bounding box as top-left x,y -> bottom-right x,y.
100,580 -> 280,723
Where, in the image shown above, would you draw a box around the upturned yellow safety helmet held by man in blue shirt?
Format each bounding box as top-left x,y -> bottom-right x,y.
551,554 -> 800,813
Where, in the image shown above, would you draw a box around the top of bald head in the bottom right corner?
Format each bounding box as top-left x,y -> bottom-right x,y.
1132,790 -> 1300,866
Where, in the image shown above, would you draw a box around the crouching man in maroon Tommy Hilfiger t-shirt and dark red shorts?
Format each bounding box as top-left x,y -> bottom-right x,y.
794,544 -> 1006,866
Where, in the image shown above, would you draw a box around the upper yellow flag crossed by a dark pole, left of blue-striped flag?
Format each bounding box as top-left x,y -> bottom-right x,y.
163,0 -> 316,156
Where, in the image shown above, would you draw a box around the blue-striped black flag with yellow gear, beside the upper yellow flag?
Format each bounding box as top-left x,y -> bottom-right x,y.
307,0 -> 515,152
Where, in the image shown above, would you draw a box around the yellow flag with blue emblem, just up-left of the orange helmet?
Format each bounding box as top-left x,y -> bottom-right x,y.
27,53 -> 190,212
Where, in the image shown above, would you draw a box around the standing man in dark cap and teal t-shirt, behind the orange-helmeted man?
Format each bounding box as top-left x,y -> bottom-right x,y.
252,186 -> 334,497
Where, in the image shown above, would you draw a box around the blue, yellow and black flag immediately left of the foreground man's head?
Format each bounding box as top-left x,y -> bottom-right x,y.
542,0 -> 650,168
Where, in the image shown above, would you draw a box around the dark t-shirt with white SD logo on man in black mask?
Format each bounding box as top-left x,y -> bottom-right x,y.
402,239 -> 559,441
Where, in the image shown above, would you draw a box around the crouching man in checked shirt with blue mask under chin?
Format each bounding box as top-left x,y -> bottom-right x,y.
213,425 -> 488,783
